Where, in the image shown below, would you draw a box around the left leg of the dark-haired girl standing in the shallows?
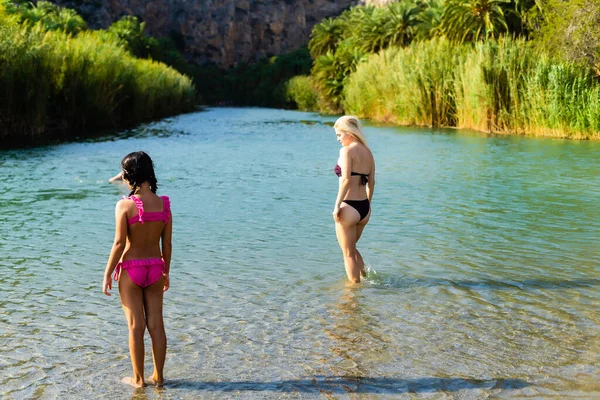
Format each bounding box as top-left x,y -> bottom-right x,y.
119,271 -> 146,387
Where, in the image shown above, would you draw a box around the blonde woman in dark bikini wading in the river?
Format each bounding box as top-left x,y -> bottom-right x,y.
333,115 -> 375,283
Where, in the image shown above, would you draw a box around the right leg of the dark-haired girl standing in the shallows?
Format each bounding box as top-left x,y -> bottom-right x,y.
144,278 -> 167,386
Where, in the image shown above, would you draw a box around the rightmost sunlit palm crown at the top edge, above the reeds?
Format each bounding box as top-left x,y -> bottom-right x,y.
442,0 -> 510,43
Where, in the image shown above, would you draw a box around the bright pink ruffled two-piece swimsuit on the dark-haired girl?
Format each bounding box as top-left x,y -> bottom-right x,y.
114,196 -> 171,288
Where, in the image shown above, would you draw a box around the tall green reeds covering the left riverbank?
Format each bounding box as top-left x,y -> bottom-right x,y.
0,7 -> 195,146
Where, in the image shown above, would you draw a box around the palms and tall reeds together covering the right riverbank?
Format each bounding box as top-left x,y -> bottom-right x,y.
287,0 -> 600,139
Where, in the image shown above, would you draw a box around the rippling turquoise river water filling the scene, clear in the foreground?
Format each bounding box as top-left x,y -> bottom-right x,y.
0,108 -> 600,399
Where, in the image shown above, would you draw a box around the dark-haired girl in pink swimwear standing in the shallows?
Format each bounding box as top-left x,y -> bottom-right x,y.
102,151 -> 173,387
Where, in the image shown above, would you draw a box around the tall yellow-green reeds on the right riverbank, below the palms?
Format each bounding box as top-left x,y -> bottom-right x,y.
343,38 -> 600,139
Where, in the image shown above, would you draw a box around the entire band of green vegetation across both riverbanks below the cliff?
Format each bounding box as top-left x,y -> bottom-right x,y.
0,0 -> 600,147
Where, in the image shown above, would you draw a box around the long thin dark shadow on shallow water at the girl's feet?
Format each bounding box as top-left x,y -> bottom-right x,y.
165,375 -> 529,394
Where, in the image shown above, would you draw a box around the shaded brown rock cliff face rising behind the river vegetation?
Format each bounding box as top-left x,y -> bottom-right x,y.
55,0 -> 360,68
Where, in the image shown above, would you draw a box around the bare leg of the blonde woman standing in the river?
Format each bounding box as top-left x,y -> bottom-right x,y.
335,205 -> 363,283
